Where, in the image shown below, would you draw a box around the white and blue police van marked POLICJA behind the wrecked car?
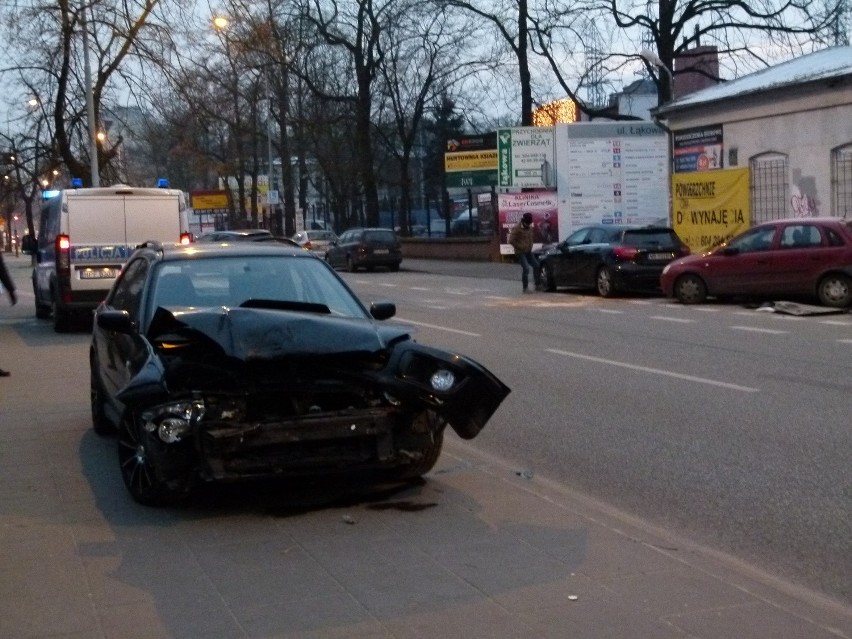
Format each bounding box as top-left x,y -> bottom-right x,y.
28,185 -> 192,332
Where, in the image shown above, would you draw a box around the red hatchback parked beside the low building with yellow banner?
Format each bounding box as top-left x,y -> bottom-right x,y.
660,217 -> 852,308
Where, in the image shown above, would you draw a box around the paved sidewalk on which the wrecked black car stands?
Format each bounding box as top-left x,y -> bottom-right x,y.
0,251 -> 852,639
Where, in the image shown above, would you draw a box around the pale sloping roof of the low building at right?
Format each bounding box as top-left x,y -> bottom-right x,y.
656,46 -> 852,115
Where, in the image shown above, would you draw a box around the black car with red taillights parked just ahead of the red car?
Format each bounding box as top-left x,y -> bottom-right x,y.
538,224 -> 689,297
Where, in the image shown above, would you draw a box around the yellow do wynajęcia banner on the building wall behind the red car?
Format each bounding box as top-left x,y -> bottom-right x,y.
672,168 -> 751,253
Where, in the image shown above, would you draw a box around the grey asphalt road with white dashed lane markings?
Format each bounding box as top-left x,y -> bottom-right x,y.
344,261 -> 852,601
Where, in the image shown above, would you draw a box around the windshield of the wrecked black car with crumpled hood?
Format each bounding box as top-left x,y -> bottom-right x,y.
147,255 -> 368,321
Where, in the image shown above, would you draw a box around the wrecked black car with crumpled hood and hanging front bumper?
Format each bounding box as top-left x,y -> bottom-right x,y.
90,242 -> 509,506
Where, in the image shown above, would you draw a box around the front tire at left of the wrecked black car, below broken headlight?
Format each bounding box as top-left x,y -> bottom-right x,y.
118,415 -> 194,507
